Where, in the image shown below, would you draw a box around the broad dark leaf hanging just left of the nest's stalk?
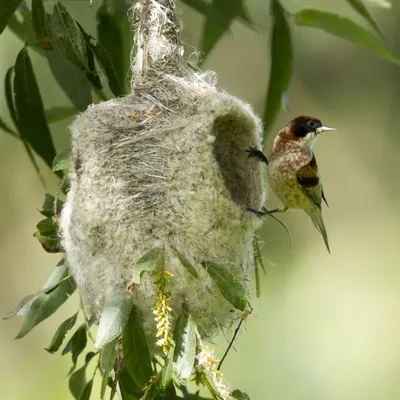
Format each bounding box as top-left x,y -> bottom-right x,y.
93,2 -> 124,96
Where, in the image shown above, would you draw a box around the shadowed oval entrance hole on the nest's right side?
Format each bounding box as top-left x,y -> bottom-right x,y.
213,114 -> 262,208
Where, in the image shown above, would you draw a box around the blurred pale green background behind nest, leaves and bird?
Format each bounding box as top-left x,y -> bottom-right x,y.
0,0 -> 400,400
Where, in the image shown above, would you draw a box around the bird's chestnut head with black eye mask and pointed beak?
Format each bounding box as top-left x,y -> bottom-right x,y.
279,116 -> 335,149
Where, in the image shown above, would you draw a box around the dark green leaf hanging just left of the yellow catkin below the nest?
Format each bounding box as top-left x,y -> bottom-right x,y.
122,308 -> 153,388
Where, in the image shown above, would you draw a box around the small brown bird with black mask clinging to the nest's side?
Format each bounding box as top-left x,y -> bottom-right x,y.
246,116 -> 335,253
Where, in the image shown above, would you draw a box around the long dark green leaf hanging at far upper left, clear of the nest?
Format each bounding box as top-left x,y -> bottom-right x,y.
14,47 -> 56,167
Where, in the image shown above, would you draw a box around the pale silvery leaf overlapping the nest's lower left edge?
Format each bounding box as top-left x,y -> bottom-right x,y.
95,288 -> 133,349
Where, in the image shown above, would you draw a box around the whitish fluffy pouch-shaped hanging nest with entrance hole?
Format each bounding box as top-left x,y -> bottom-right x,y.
61,0 -> 265,344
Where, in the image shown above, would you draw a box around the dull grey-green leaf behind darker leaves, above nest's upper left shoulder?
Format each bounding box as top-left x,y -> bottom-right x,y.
46,44 -> 93,111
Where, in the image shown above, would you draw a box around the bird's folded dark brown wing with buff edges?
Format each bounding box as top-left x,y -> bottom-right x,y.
296,154 -> 328,208
